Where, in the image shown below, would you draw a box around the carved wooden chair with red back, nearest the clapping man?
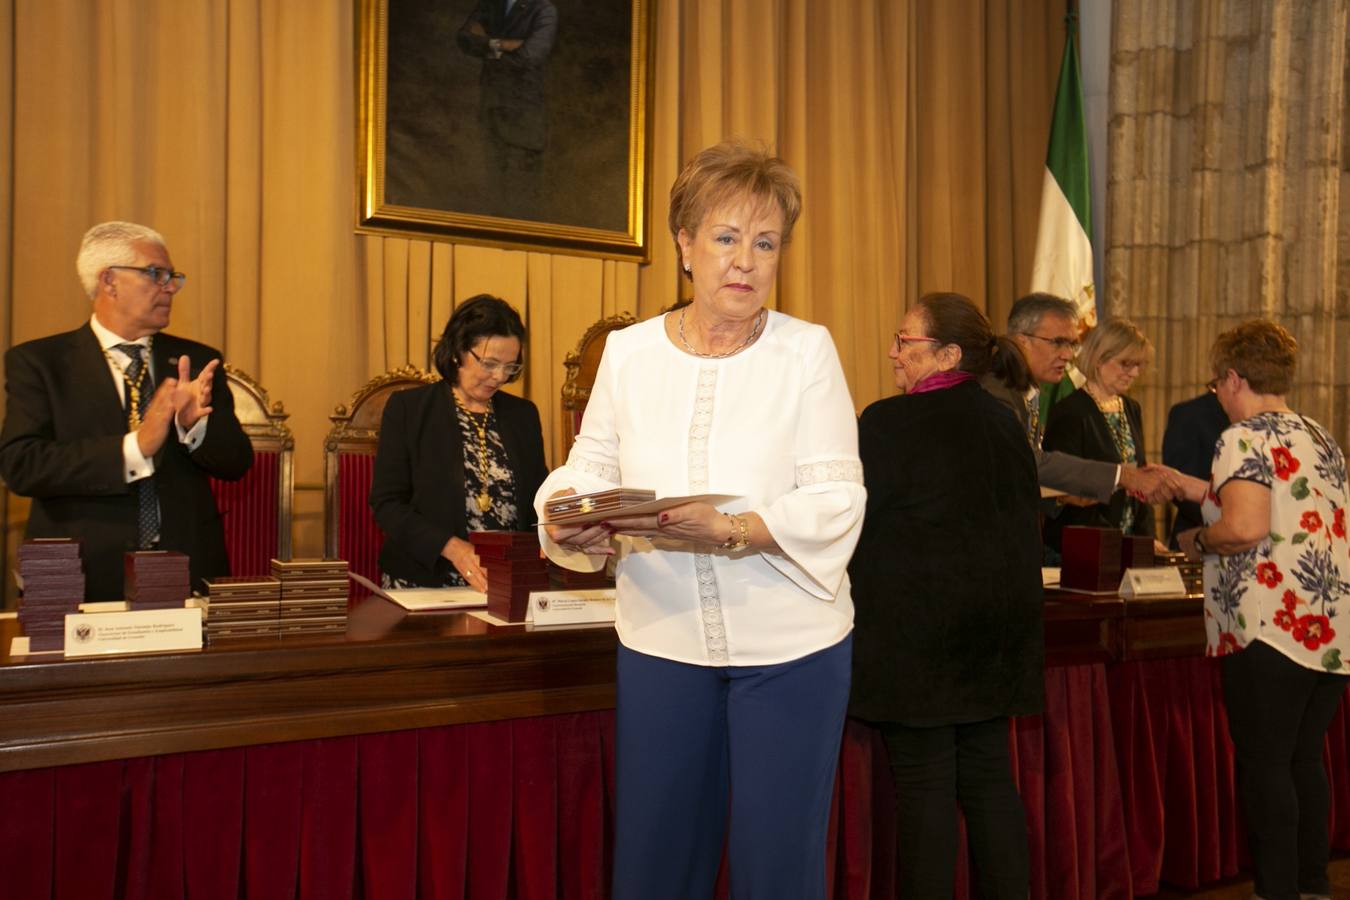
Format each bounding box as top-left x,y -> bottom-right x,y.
208,363 -> 296,575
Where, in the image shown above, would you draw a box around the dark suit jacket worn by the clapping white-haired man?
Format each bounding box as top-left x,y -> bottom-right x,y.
0,324 -> 252,600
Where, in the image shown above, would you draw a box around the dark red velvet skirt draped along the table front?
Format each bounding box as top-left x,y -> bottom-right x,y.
0,660 -> 1350,900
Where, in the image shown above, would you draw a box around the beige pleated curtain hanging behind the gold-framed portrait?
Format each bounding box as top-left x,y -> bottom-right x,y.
0,0 -> 1064,566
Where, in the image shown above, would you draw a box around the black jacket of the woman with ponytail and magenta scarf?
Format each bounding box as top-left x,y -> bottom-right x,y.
849,382 -> 1045,726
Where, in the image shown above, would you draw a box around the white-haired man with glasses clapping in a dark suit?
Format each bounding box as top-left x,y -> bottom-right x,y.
0,221 -> 252,600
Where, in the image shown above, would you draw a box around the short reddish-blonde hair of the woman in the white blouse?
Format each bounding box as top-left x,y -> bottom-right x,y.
667,140 -> 802,277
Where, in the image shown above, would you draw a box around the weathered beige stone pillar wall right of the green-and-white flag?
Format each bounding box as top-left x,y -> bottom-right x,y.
1107,0 -> 1350,455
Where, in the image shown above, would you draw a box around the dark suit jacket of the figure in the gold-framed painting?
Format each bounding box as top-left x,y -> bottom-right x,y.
455,0 -> 558,150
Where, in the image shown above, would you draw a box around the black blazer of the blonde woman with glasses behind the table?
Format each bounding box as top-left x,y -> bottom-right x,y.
1045,387 -> 1157,551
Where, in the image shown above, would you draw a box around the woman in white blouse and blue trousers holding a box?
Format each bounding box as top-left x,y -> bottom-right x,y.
536,143 -> 865,900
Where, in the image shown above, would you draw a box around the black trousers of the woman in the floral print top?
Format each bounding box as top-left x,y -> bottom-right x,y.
1222,641 -> 1350,900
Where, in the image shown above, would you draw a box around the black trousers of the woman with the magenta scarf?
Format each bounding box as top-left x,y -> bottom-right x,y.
878,718 -> 1030,900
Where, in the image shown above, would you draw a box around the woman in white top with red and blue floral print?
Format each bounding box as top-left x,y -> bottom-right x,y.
1179,320 -> 1350,900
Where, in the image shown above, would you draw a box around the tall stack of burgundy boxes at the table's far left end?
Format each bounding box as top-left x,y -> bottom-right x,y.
19,538 -> 85,653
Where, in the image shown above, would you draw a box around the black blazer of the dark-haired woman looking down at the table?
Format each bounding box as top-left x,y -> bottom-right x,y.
370,382 -> 548,587
